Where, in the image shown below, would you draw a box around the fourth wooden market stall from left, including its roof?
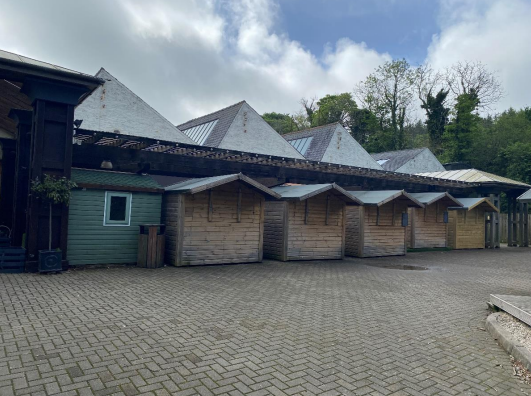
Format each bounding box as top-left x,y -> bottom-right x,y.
406,192 -> 462,249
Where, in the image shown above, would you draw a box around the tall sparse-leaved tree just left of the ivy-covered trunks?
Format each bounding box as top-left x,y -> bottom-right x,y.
355,59 -> 416,150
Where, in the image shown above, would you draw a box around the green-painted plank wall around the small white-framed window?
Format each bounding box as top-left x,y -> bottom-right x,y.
67,190 -> 162,265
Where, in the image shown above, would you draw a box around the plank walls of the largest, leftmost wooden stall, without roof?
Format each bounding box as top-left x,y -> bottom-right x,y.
164,181 -> 265,266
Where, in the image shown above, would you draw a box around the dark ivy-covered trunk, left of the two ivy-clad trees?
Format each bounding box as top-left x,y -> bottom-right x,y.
420,89 -> 450,155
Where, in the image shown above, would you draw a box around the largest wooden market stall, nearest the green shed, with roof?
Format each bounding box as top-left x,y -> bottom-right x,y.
162,173 -> 279,266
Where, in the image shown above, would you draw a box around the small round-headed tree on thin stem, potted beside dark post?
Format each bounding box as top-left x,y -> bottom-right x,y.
31,175 -> 77,250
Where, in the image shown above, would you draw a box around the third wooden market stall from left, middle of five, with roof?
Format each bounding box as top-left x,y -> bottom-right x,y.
346,190 -> 423,257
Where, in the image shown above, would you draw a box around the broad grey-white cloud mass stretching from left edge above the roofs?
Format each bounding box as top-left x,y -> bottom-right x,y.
0,0 -> 390,123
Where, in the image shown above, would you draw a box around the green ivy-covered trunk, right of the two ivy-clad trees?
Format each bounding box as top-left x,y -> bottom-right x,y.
442,90 -> 480,162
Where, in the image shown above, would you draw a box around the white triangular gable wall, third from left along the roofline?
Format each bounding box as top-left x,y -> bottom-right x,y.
321,125 -> 383,170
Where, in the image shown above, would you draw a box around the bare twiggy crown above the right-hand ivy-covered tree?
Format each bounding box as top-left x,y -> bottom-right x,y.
445,62 -> 503,110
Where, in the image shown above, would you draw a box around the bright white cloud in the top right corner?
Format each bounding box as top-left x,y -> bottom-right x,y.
427,0 -> 531,111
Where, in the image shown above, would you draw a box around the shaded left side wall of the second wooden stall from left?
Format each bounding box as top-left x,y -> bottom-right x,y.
264,201 -> 288,261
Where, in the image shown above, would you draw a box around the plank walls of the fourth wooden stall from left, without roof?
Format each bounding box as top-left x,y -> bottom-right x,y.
406,204 -> 448,249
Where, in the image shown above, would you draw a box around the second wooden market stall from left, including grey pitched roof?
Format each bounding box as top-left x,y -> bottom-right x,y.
264,183 -> 359,261
